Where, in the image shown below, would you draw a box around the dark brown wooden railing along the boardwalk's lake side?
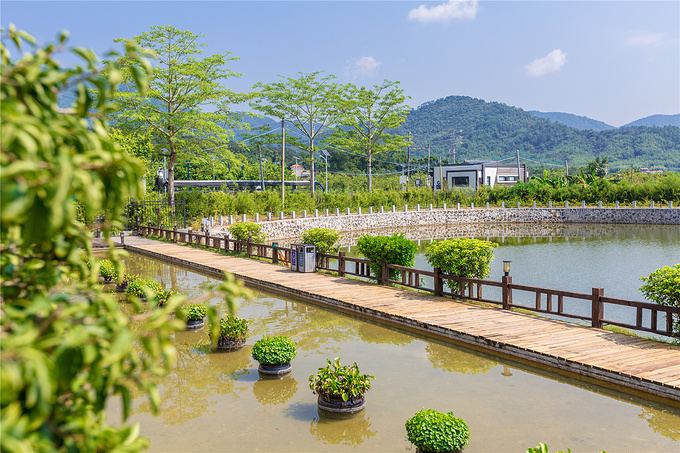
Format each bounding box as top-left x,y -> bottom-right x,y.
137,224 -> 680,338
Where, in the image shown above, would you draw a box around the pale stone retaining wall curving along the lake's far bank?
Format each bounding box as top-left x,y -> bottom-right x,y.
213,208 -> 680,239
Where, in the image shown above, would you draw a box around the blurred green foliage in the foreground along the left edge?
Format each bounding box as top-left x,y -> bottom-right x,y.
0,26 -> 183,453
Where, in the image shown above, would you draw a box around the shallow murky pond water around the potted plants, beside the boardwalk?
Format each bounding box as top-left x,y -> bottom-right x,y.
102,255 -> 680,452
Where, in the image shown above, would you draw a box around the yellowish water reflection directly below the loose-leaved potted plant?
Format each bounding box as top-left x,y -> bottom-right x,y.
309,410 -> 377,447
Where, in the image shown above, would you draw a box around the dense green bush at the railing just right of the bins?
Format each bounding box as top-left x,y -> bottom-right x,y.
357,233 -> 418,279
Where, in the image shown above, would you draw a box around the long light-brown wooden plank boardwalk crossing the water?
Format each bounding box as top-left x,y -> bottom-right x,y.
117,236 -> 680,404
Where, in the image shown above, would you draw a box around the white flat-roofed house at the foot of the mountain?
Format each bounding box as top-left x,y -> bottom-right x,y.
430,161 -> 529,190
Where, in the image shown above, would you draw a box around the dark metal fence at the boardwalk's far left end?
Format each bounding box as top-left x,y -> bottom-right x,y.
125,195 -> 187,230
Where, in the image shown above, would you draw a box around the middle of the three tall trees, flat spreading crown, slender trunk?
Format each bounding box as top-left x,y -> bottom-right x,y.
250,71 -> 339,195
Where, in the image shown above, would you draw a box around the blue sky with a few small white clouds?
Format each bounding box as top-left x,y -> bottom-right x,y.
0,0 -> 680,126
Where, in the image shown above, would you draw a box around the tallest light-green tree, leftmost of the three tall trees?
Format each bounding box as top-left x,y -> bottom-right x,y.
106,26 -> 246,202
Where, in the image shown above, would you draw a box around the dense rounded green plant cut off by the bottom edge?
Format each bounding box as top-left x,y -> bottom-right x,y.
406,409 -> 470,452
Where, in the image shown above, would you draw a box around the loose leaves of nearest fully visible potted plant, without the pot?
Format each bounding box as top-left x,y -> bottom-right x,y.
309,357 -> 375,401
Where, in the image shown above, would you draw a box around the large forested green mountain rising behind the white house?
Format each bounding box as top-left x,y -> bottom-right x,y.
398,96 -> 680,171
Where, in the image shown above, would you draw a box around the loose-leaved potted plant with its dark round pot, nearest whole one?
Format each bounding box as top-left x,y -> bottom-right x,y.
309,358 -> 375,414
